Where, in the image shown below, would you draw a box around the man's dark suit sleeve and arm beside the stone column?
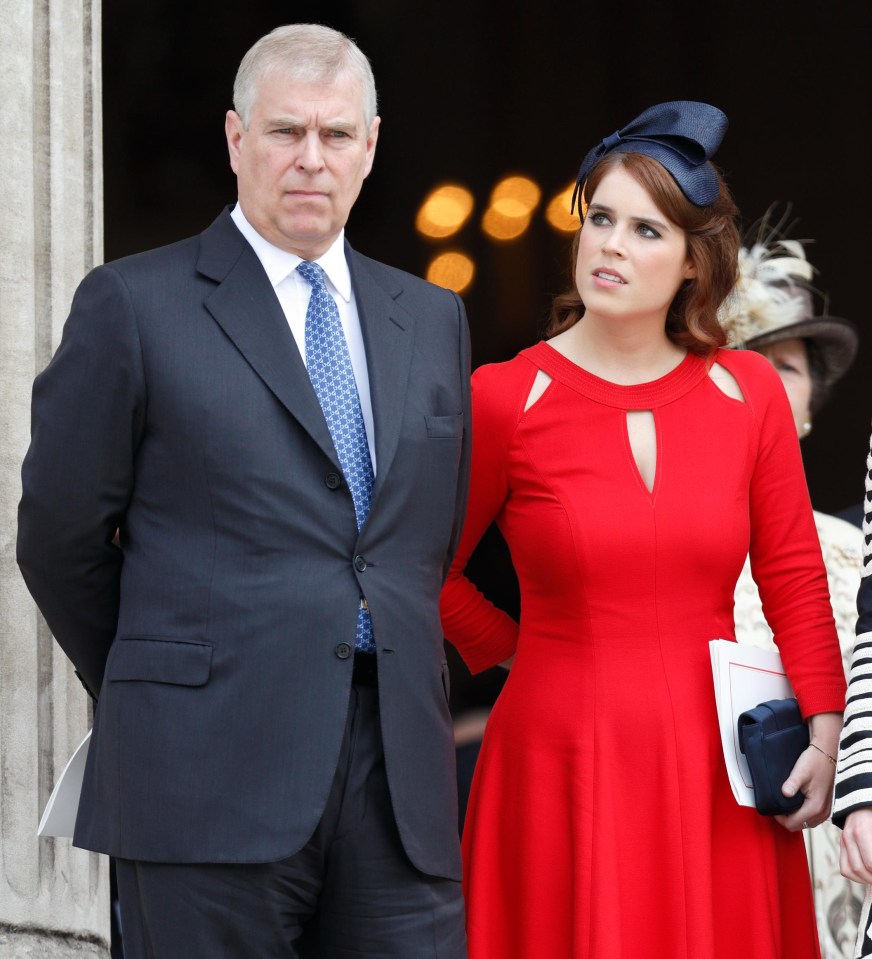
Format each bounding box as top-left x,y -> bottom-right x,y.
17,267 -> 146,698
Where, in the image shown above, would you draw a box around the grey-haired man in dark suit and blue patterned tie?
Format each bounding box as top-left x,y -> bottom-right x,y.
18,24 -> 469,959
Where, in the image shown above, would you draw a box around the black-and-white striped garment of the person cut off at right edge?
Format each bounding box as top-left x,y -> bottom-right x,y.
833,438 -> 872,957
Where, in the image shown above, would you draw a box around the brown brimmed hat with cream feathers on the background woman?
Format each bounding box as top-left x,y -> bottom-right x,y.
718,211 -> 859,389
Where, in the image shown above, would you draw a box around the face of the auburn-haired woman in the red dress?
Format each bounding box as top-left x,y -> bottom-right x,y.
575,167 -> 696,323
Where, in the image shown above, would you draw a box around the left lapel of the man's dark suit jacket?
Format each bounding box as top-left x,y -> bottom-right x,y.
198,211 -> 339,476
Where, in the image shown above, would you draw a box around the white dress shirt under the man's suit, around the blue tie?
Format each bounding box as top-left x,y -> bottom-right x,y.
230,203 -> 376,476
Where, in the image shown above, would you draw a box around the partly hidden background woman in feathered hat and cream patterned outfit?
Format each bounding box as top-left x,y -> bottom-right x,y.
720,218 -> 863,959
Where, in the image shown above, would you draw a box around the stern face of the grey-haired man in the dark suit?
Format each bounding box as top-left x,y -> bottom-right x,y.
225,71 -> 379,260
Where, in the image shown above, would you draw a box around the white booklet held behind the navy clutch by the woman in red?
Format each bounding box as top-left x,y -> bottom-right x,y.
709,639 -> 794,806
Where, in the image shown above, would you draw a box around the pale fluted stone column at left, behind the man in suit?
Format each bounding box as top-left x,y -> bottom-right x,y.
0,0 -> 109,959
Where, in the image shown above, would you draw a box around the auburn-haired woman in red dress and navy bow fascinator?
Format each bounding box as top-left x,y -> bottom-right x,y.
443,102 -> 844,959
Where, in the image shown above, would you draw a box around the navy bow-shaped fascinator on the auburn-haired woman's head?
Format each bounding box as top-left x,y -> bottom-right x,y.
571,100 -> 728,217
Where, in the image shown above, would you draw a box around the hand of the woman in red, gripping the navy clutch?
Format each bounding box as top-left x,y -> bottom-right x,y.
775,713 -> 840,836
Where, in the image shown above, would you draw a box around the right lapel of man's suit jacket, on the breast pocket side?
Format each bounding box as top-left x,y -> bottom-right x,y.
345,244 -> 415,507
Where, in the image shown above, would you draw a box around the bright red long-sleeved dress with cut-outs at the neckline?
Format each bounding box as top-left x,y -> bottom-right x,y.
442,342 -> 845,959
